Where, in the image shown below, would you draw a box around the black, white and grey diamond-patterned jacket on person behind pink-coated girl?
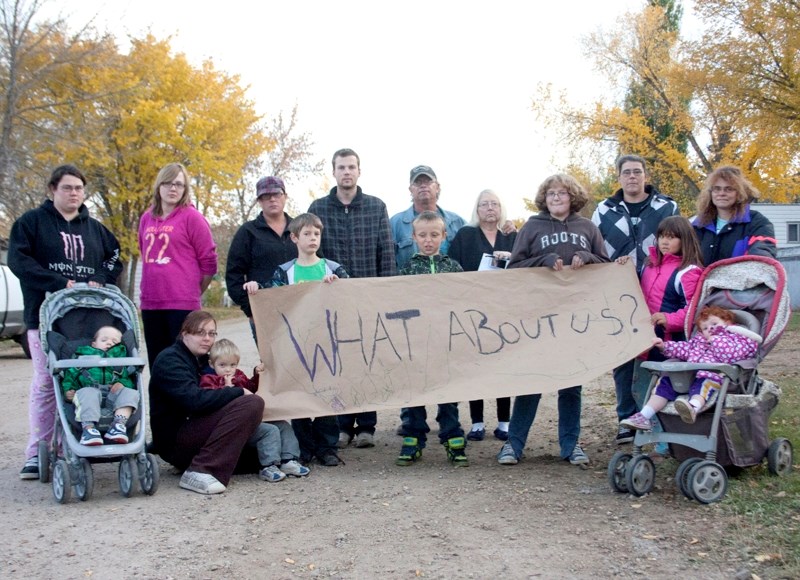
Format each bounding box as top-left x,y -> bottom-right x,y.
592,185 -> 681,274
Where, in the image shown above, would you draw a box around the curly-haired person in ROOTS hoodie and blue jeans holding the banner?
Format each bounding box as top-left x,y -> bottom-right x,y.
497,174 -> 609,465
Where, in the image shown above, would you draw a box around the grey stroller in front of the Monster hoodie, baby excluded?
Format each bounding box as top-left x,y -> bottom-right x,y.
39,284 -> 159,503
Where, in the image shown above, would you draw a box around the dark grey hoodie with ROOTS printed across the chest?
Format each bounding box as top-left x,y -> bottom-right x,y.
508,211 -> 609,268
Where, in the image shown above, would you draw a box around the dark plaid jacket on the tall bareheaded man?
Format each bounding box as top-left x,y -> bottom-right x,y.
308,187 -> 397,278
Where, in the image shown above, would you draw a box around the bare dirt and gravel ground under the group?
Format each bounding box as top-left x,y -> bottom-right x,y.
0,319 -> 798,579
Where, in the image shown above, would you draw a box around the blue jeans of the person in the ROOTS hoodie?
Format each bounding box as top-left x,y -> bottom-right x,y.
508,386 -> 581,459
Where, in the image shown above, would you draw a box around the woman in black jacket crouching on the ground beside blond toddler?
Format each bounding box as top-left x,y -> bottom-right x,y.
149,310 -> 264,495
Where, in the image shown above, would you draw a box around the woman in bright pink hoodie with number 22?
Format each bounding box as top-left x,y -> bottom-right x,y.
139,163 -> 217,369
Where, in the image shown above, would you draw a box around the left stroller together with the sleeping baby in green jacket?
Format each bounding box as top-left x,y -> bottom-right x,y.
38,284 -> 159,503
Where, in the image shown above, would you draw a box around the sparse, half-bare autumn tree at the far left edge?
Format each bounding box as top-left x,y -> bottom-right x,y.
0,0 -> 119,234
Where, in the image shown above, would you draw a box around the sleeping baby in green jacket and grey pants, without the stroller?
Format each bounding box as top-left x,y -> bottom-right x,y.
61,326 -> 139,445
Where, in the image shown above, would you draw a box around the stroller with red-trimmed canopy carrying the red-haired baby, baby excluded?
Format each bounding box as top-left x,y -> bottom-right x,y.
608,256 -> 793,503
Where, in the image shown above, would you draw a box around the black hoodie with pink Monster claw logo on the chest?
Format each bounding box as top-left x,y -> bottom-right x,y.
8,199 -> 122,328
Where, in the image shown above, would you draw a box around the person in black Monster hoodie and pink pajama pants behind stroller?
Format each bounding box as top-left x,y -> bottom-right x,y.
8,165 -> 122,479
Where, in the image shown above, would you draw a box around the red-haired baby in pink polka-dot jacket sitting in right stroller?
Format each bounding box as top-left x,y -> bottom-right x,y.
621,306 -> 762,431
